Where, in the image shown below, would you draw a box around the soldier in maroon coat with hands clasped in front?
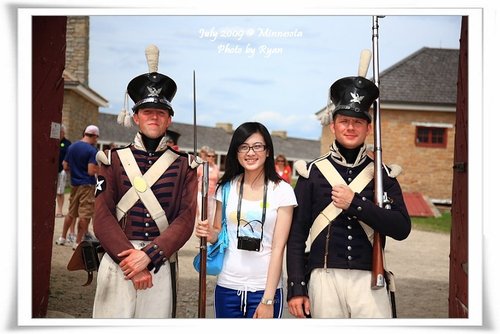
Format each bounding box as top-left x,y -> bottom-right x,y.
93,47 -> 198,318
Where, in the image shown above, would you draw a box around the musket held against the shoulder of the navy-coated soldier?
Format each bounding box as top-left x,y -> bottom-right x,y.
371,15 -> 397,318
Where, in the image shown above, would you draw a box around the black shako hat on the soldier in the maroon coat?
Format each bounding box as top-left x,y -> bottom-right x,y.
127,72 -> 177,116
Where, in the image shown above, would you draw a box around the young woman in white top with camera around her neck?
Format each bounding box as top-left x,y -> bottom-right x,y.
195,122 -> 297,318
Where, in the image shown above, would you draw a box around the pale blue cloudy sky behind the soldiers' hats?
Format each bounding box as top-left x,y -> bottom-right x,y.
89,12 -> 461,139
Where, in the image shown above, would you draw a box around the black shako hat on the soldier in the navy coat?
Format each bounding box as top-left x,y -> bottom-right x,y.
330,77 -> 379,123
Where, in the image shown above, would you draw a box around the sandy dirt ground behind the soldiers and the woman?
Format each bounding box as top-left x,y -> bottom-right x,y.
48,196 -> 450,318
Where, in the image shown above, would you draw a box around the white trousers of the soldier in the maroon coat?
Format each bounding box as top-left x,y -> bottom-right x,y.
92,240 -> 172,319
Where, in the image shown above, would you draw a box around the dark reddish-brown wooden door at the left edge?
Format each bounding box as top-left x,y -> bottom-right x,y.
31,16 -> 66,318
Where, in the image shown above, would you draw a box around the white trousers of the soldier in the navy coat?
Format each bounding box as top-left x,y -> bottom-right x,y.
309,268 -> 392,319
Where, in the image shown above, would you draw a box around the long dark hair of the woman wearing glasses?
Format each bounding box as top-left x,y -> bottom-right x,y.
217,122 -> 281,188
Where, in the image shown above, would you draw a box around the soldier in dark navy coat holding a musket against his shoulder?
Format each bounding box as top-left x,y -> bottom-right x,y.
286,77 -> 411,318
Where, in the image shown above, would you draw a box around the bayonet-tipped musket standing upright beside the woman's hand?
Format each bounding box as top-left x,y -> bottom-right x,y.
193,71 -> 208,318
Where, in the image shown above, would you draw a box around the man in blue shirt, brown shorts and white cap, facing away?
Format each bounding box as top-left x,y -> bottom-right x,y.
56,125 -> 99,249
